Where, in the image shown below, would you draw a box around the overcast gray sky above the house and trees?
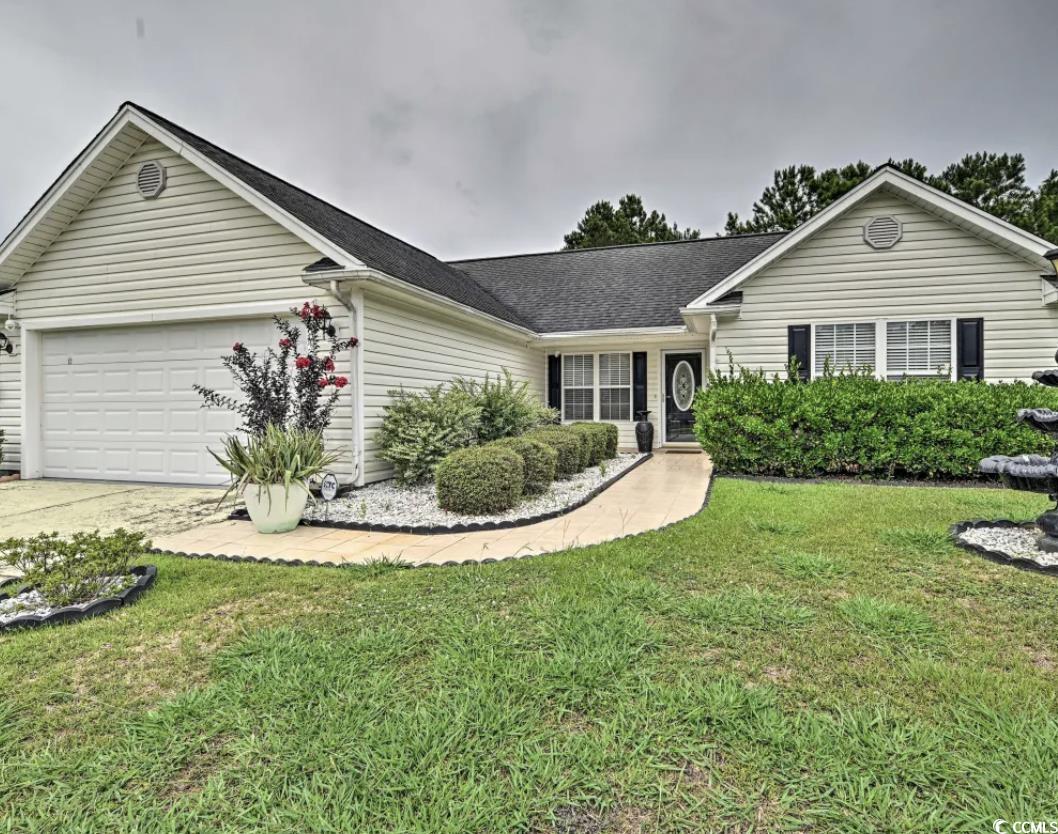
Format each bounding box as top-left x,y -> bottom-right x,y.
0,0 -> 1058,258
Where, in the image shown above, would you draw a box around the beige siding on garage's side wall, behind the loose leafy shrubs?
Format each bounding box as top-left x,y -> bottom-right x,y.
361,294 -> 547,484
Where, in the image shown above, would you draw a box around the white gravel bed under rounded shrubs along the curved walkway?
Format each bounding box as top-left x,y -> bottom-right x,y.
305,454 -> 643,527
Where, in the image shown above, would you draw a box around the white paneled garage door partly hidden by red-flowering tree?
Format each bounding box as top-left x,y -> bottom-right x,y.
40,319 -> 275,484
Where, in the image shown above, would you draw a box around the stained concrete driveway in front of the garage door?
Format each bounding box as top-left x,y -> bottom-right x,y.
0,479 -> 231,539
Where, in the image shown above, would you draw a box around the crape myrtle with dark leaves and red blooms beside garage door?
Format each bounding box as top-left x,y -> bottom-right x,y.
194,302 -> 358,437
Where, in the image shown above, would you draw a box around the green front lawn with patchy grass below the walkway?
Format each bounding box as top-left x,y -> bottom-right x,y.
0,481 -> 1058,834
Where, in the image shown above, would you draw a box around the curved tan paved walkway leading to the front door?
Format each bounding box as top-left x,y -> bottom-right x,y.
154,452 -> 712,564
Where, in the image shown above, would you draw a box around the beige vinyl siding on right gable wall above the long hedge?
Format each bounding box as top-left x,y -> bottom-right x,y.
714,192 -> 1058,380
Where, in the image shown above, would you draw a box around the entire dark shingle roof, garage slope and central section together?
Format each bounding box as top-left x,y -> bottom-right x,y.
128,102 -> 783,332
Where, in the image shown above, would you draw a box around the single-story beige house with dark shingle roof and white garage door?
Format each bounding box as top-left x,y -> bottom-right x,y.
0,103 -> 1058,484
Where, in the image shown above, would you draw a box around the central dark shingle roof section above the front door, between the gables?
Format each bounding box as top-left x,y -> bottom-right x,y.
452,232 -> 786,332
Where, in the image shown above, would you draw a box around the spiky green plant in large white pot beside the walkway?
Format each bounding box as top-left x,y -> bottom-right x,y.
209,424 -> 339,533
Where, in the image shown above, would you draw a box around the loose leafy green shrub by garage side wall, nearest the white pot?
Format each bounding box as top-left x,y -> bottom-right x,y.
378,385 -> 481,485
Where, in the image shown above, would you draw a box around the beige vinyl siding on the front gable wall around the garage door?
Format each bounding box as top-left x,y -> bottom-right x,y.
0,140 -> 352,475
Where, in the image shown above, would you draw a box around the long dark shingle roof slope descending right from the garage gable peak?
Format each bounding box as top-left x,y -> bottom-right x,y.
128,102 -> 528,327
